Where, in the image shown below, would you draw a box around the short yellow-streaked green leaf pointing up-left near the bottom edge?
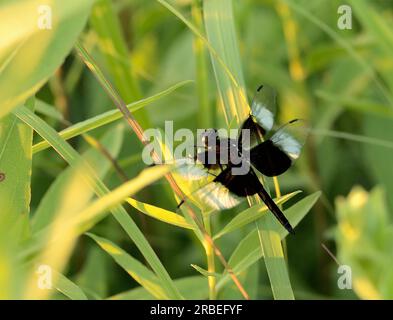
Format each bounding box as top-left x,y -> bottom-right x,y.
87,233 -> 168,299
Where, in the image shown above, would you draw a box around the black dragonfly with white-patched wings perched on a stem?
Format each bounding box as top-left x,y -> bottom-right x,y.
178,85 -> 308,233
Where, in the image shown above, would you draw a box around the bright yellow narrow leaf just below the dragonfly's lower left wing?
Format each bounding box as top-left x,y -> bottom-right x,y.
126,198 -> 194,229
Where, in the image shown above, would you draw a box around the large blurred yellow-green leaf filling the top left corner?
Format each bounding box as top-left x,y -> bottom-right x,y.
0,0 -> 93,117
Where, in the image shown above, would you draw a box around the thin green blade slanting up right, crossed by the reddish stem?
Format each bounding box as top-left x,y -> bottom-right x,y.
33,80 -> 192,153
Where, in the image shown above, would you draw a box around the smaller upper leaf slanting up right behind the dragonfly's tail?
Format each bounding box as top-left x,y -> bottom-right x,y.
213,191 -> 301,239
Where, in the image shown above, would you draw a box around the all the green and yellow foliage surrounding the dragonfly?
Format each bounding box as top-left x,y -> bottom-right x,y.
0,0 -> 393,299
